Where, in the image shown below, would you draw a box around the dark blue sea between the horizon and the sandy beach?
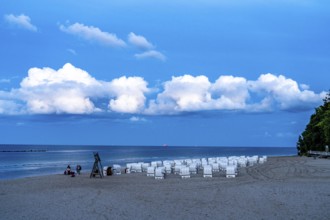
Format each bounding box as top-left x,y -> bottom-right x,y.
0,145 -> 297,180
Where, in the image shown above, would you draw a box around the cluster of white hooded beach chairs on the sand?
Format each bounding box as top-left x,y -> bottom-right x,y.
113,156 -> 267,179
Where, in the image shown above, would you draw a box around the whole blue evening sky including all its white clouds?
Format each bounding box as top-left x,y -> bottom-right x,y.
0,0 -> 330,147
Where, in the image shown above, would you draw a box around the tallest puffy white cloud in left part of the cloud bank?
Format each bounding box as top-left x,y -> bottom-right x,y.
19,63 -> 102,114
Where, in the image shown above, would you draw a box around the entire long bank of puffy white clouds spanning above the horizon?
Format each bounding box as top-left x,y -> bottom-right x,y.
0,63 -> 326,115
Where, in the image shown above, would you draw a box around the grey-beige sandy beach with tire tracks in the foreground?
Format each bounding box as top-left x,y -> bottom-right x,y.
0,157 -> 330,220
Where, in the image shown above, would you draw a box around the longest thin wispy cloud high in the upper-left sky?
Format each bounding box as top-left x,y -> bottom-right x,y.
60,23 -> 126,47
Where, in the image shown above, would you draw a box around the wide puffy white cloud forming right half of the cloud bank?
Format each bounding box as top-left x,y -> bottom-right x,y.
145,73 -> 325,114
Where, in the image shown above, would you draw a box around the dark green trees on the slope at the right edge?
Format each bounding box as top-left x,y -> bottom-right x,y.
297,91 -> 330,155
